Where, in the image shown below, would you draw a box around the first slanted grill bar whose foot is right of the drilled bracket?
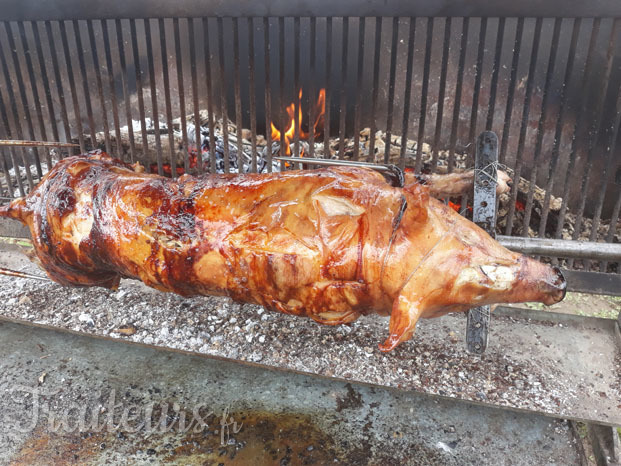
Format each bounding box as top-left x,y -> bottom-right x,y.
505,18 -> 542,235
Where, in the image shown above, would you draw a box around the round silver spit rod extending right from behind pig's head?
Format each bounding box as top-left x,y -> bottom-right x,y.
496,236 -> 621,261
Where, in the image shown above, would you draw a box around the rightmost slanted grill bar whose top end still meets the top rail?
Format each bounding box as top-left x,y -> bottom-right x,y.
567,19 -> 621,270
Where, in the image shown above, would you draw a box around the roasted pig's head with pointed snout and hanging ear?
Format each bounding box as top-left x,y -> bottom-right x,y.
380,198 -> 567,351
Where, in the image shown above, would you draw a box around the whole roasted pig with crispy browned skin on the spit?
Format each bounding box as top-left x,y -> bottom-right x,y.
0,154 -> 565,351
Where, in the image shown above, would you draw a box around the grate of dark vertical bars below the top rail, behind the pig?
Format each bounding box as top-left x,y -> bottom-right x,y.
0,5 -> 621,271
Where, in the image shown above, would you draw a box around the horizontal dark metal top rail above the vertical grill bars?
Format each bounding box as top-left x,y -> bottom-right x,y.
3,0 -> 621,21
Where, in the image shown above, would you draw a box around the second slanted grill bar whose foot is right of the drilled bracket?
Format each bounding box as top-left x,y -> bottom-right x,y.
516,18 -> 562,237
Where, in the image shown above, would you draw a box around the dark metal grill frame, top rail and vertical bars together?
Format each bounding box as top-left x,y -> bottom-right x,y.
0,0 -> 621,292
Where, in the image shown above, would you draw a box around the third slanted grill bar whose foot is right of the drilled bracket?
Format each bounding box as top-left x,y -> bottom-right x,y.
539,18 -> 582,238
